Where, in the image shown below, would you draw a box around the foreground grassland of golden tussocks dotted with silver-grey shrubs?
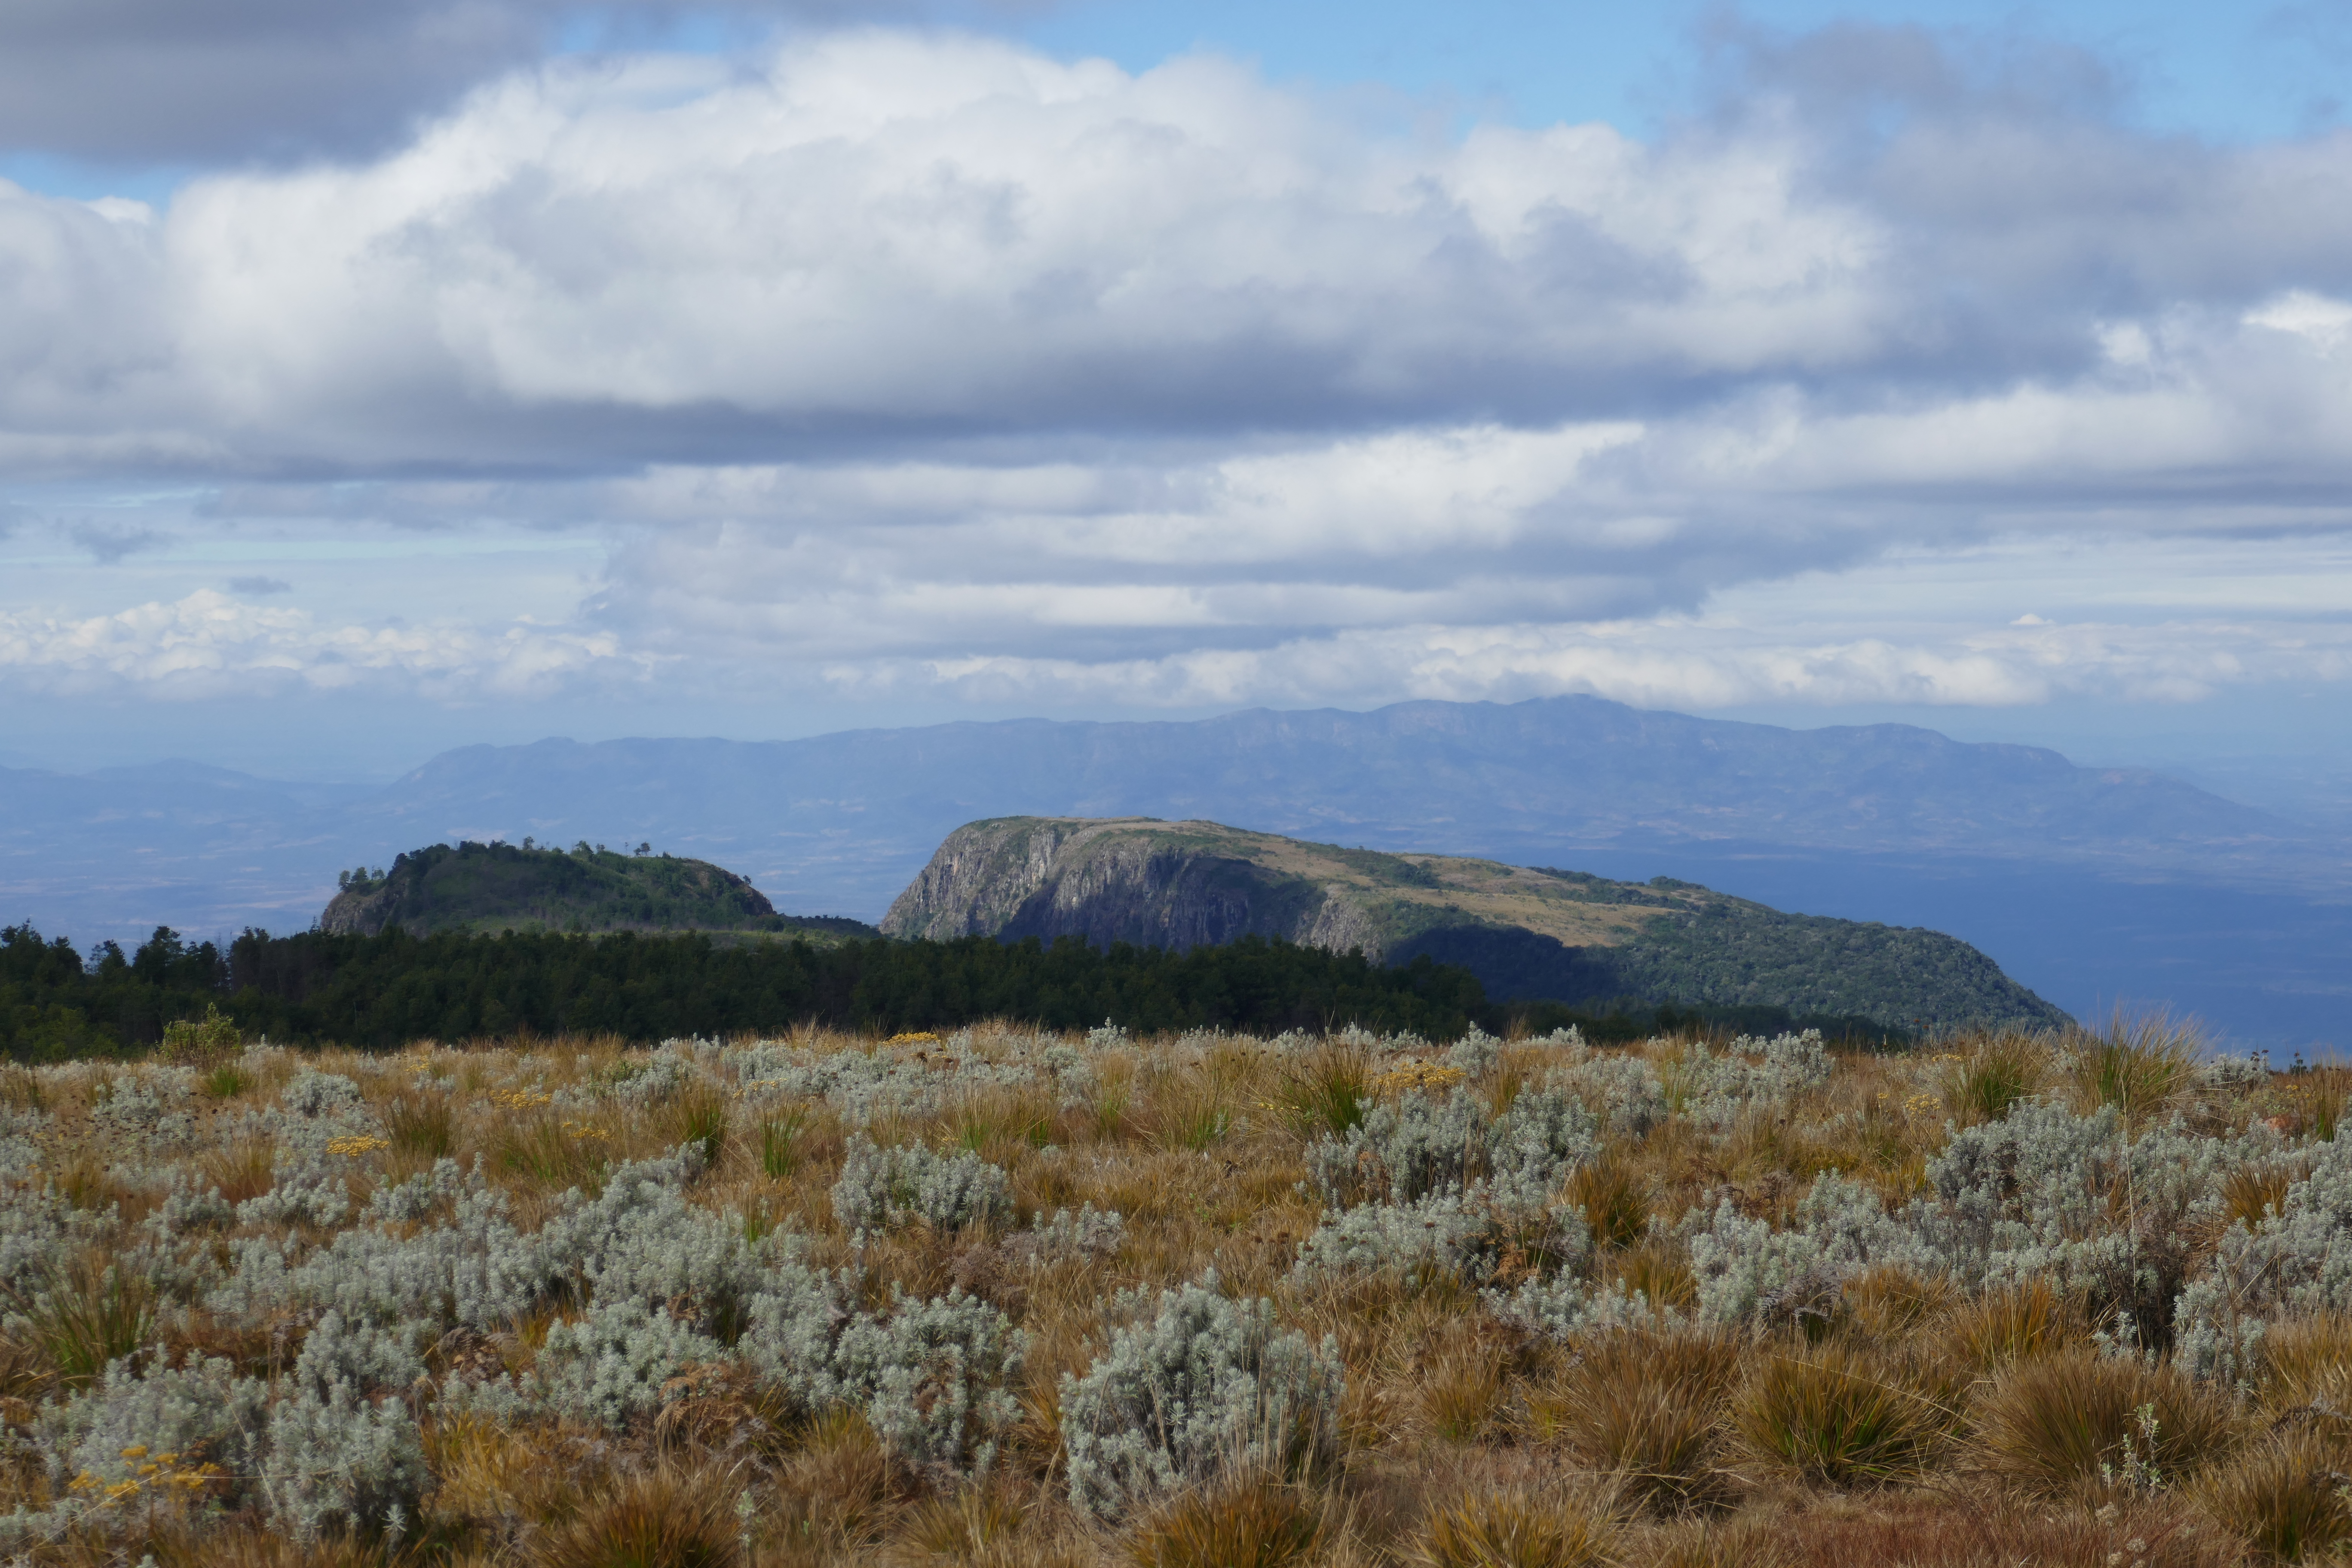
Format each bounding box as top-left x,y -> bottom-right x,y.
0,1011 -> 2352,1568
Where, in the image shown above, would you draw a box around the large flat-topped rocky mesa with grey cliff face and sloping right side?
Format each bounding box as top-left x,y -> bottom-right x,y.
882,816 -> 2065,1027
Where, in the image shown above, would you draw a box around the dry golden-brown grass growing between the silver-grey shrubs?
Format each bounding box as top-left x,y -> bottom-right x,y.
0,1027 -> 2352,1568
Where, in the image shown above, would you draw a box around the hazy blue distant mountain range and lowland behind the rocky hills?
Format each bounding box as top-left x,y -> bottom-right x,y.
0,698 -> 2352,1044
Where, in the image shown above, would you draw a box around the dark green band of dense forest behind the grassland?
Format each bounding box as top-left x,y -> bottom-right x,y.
0,926 -> 1889,1060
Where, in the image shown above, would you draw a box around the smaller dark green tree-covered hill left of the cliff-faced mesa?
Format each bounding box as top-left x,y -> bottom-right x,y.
318,842 -> 875,940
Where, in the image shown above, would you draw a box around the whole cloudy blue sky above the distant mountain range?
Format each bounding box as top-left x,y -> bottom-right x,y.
0,0 -> 2352,823
